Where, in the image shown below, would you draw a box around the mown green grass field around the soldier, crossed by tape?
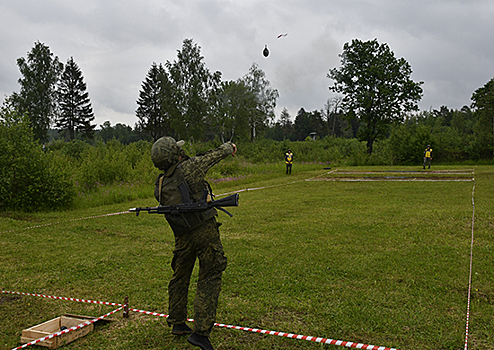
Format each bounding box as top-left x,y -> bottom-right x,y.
0,164 -> 494,350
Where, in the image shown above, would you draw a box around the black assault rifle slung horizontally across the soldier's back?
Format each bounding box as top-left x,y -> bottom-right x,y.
129,190 -> 238,216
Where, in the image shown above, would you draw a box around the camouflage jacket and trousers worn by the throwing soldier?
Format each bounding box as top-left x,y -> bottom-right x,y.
152,138 -> 234,336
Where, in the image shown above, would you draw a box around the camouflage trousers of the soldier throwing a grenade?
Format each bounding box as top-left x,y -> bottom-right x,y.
167,218 -> 227,336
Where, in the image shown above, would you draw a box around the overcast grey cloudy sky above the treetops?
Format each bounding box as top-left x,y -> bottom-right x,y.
0,0 -> 494,128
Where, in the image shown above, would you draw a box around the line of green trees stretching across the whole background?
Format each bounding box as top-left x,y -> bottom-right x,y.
4,39 -> 494,160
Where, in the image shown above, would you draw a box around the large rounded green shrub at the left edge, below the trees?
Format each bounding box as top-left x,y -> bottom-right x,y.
0,106 -> 74,211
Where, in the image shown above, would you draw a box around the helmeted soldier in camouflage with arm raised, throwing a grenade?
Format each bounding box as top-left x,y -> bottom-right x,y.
151,137 -> 237,350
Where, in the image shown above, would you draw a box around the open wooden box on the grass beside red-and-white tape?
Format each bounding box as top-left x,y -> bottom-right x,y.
21,315 -> 94,349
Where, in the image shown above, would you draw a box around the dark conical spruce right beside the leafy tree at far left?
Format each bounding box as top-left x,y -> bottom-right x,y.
55,57 -> 96,140
